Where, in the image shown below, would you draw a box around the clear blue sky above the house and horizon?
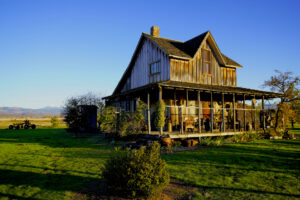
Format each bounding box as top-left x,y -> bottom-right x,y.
0,0 -> 300,108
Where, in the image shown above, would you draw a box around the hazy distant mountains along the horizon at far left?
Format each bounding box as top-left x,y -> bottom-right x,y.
0,107 -> 63,117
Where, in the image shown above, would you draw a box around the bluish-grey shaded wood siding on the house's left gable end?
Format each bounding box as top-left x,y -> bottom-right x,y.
121,39 -> 170,92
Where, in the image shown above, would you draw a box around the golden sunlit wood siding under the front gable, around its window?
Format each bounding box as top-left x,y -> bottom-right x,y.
170,42 -> 237,86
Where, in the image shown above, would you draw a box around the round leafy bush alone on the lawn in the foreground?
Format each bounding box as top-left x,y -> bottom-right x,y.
103,142 -> 169,198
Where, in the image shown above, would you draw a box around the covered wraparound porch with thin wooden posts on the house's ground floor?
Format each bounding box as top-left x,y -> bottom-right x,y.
104,81 -> 279,138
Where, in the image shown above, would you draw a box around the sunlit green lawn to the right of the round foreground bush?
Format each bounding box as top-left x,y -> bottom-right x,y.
163,140 -> 300,199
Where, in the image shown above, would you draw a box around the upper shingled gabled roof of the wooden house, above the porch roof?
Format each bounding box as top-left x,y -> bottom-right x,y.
113,31 -> 242,94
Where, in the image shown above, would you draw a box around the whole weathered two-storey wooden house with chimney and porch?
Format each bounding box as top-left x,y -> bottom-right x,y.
104,26 -> 278,133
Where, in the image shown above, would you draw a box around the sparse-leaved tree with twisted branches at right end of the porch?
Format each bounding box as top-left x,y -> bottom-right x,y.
263,70 -> 300,131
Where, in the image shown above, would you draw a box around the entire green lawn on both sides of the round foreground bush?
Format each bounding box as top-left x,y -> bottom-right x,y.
0,129 -> 300,200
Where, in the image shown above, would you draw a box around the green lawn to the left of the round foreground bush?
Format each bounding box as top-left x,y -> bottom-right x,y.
0,129 -> 113,199
